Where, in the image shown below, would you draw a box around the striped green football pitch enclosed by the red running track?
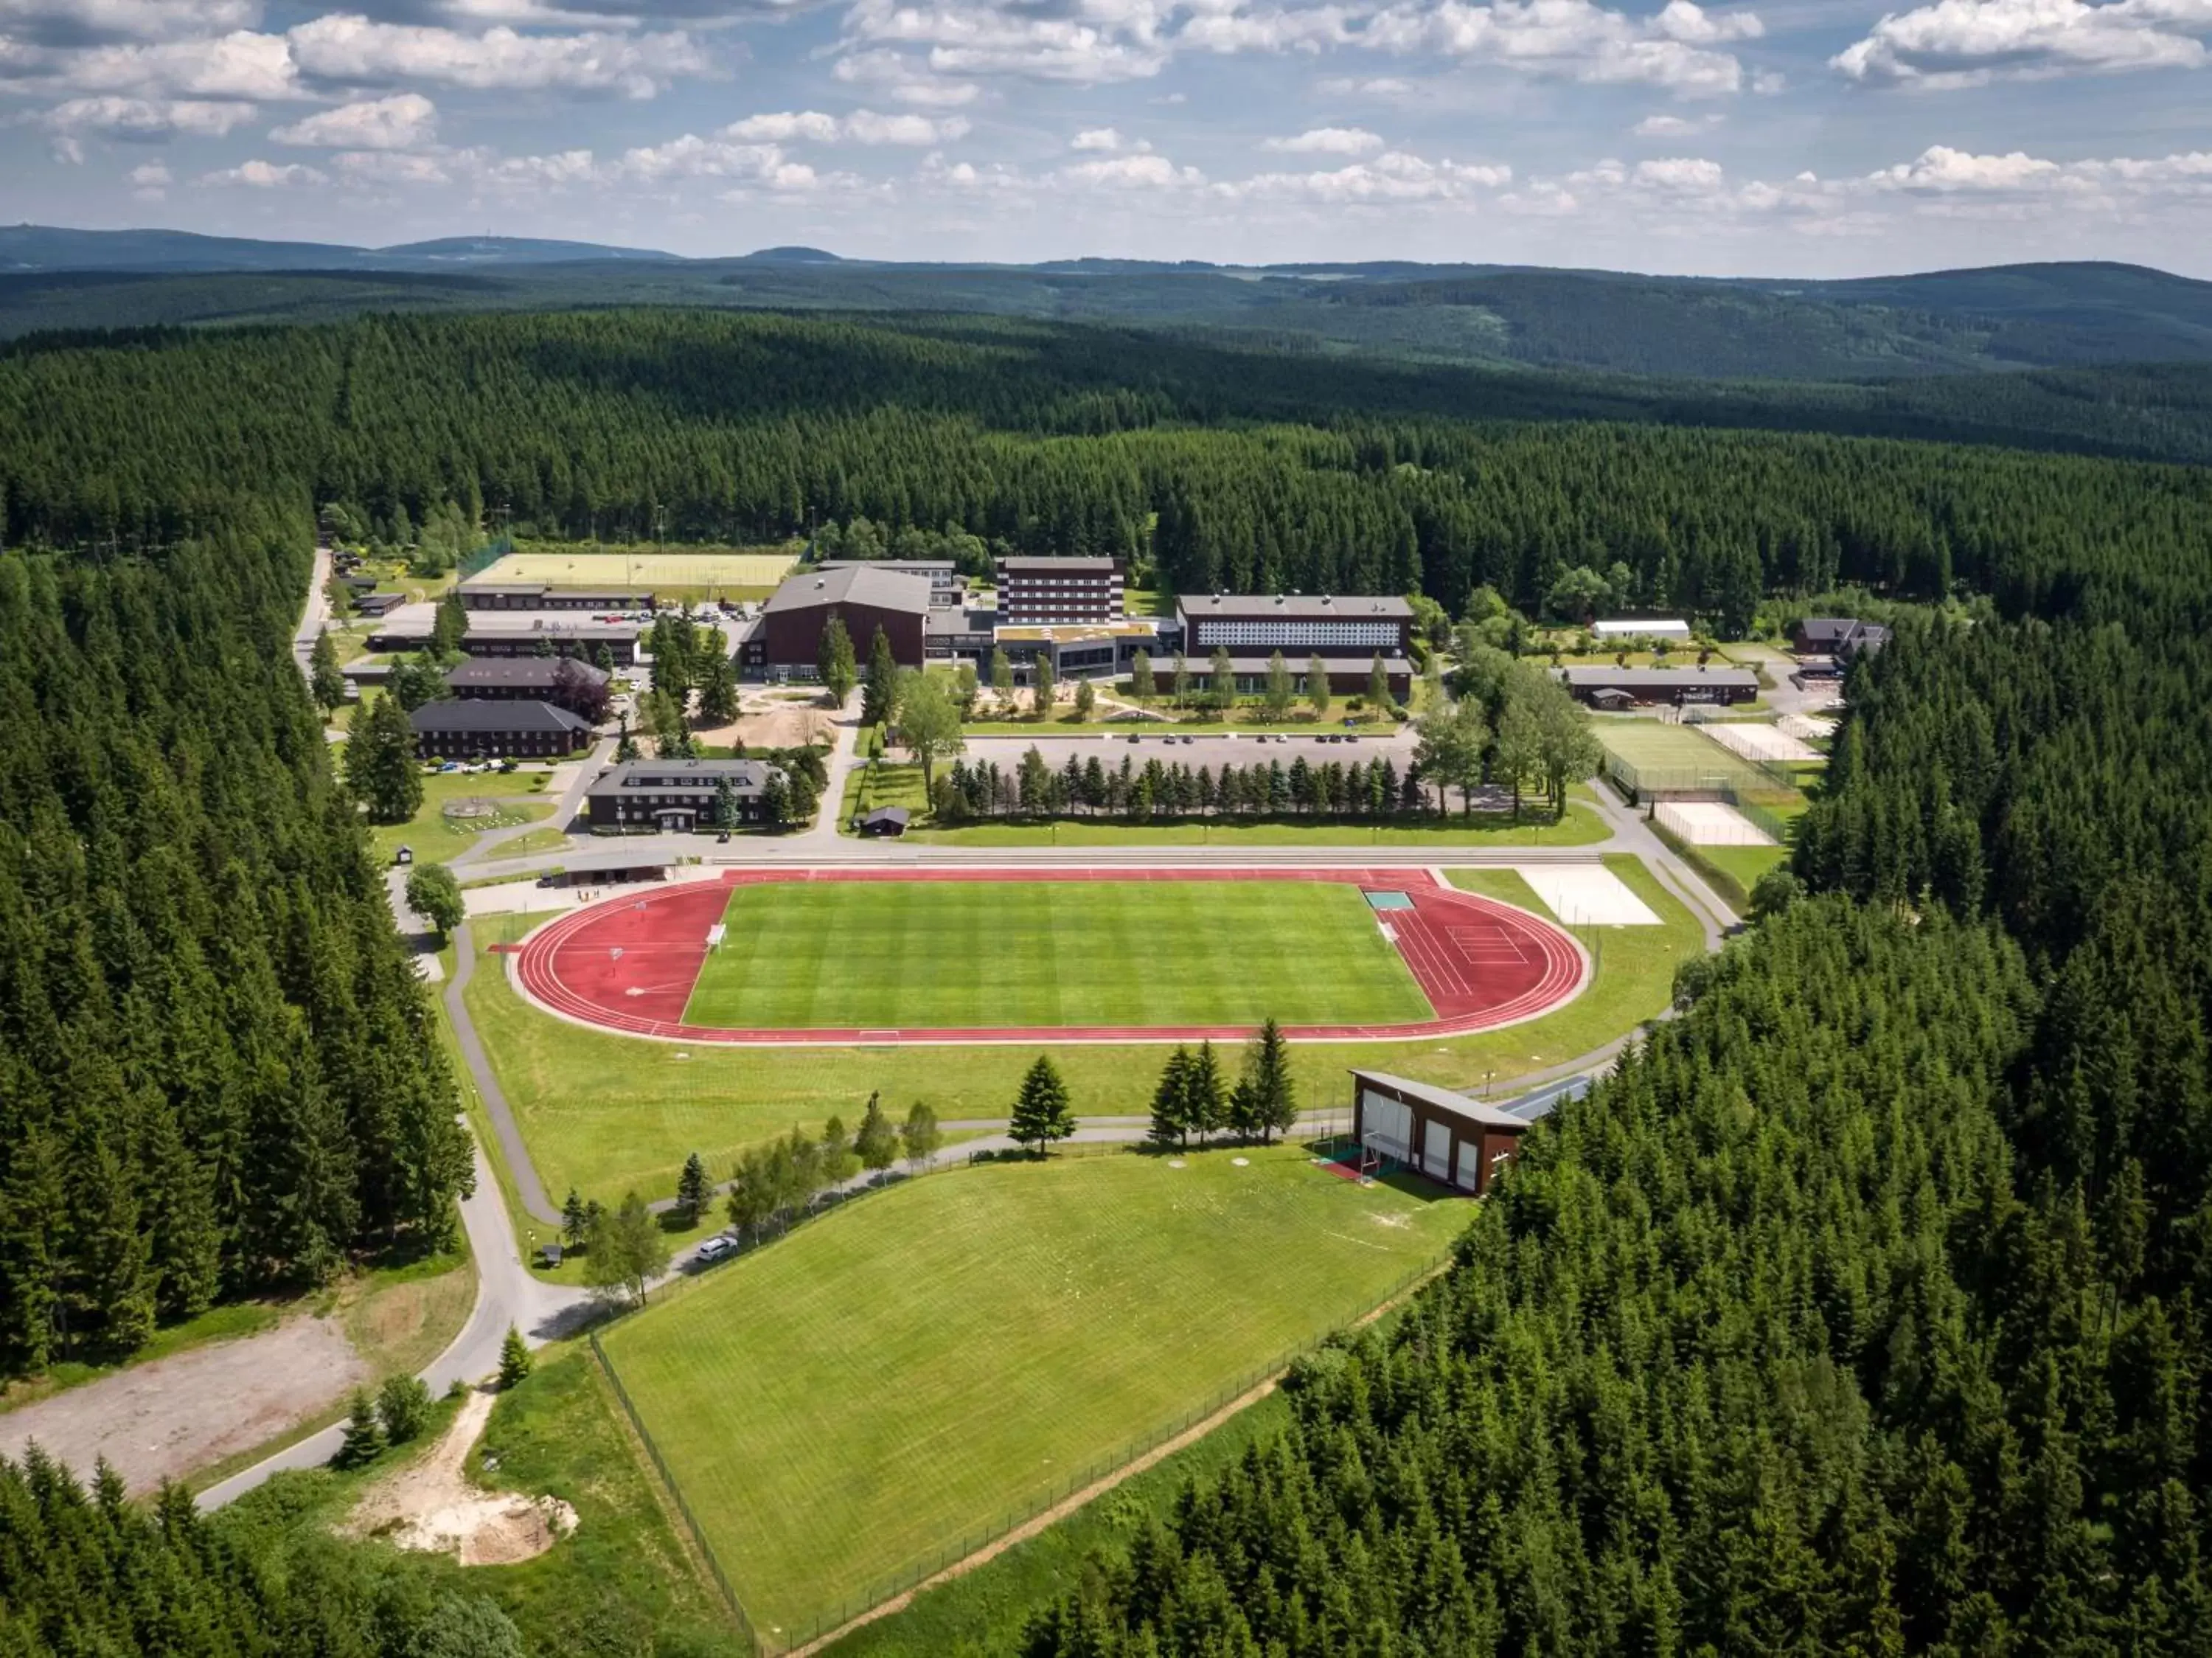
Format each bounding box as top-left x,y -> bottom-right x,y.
684,881 -> 1431,1030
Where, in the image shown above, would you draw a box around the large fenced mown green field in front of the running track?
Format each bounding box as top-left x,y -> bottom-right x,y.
604,1147 -> 1471,1647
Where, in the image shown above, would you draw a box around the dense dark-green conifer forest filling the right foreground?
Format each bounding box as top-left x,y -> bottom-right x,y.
1022,398 -> 2212,1658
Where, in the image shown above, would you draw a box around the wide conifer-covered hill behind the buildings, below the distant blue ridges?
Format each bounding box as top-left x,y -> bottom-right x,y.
0,312 -> 2212,620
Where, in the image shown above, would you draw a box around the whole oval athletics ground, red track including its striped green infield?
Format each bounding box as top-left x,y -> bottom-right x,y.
509,866 -> 1593,1047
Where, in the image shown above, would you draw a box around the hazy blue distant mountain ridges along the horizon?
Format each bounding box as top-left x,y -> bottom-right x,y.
0,226 -> 2212,381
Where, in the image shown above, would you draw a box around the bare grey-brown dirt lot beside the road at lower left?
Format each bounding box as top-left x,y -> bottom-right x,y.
0,1317 -> 369,1492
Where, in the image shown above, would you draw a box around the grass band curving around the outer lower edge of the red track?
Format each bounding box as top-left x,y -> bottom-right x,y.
467,855 -> 1701,1202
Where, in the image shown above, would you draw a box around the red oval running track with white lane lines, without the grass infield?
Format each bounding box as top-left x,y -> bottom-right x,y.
513,868 -> 1588,1047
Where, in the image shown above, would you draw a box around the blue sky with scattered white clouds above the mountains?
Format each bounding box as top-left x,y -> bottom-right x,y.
0,0 -> 2212,277
